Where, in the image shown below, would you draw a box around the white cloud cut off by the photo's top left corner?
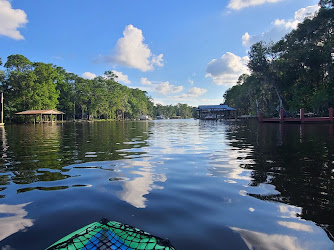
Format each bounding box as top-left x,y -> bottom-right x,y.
0,0 -> 28,40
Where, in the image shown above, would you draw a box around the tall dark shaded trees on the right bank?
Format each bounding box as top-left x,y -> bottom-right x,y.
224,0 -> 334,116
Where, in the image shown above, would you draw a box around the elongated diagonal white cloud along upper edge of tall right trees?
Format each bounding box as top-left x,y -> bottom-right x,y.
242,4 -> 319,47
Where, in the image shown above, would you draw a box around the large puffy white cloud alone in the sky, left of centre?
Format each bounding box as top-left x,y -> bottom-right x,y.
106,24 -> 163,71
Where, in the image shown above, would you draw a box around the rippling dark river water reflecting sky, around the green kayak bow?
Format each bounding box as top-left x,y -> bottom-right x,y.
0,120 -> 334,249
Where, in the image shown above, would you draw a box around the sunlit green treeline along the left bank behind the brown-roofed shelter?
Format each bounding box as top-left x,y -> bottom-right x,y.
0,55 -> 193,121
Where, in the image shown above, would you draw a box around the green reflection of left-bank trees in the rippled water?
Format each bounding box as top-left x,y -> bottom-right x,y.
0,122 -> 149,195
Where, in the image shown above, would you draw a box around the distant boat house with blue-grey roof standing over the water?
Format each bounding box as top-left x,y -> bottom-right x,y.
196,104 -> 237,120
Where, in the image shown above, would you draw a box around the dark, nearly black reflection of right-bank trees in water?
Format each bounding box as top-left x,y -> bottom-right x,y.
227,123 -> 334,240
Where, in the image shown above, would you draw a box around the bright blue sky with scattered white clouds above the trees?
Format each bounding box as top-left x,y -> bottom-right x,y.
0,0 -> 318,106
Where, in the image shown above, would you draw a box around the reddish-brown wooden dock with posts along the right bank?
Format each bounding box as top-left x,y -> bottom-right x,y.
258,108 -> 333,123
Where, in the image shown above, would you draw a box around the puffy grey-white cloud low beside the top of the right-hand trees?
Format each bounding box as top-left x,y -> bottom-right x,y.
205,52 -> 250,87
